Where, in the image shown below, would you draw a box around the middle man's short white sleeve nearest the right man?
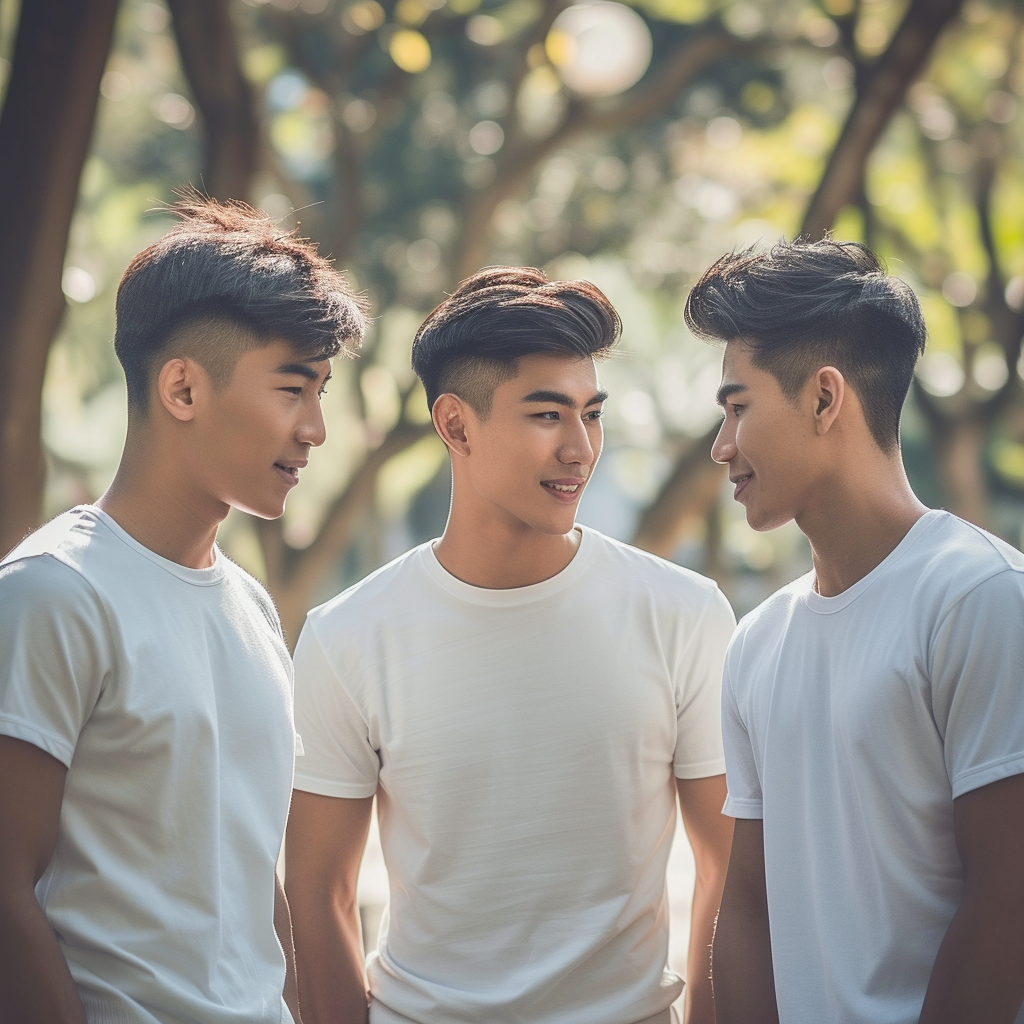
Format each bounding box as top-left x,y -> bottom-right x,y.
673,587 -> 736,778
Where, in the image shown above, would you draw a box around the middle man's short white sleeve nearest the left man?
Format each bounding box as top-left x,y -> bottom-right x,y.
295,618 -> 380,799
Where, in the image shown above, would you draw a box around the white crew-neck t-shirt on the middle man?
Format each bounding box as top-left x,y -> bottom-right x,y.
295,529 -> 734,1024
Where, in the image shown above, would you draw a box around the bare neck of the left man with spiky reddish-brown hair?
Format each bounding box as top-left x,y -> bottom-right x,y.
96,430 -> 228,569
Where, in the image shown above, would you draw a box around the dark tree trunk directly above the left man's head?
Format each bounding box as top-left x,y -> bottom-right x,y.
168,0 -> 259,201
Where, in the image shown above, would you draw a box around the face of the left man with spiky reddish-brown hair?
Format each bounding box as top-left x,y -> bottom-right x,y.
194,341 -> 331,519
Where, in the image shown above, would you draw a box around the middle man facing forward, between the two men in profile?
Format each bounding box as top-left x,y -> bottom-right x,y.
286,267 -> 734,1024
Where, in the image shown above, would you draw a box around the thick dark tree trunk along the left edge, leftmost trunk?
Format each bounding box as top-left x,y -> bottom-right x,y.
0,0 -> 118,552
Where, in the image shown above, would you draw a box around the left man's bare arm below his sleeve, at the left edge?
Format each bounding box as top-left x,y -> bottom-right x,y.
0,736 -> 86,1024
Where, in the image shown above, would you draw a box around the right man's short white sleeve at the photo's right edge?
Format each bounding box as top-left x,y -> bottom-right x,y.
930,569 -> 1024,799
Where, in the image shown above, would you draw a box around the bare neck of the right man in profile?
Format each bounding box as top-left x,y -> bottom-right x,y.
797,452 -> 928,597
